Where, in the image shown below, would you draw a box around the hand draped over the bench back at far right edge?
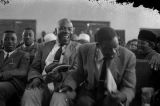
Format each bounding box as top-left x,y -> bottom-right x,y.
149,53 -> 160,71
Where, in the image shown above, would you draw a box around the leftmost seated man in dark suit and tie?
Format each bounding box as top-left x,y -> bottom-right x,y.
0,31 -> 29,106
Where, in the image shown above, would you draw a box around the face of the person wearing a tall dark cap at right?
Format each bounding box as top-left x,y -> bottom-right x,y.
137,40 -> 151,54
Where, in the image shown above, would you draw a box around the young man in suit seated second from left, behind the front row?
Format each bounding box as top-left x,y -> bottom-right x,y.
18,28 -> 40,63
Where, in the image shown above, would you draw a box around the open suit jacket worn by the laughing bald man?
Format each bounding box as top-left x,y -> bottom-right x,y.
28,41 -> 79,81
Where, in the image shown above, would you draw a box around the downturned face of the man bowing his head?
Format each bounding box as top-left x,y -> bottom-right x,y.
99,37 -> 119,59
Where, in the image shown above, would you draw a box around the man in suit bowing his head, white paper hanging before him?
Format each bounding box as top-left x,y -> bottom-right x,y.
52,27 -> 136,106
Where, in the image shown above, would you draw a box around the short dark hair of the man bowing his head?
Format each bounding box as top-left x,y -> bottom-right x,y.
95,27 -> 117,43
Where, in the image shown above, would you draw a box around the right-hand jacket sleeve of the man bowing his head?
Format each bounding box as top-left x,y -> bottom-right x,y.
120,54 -> 136,102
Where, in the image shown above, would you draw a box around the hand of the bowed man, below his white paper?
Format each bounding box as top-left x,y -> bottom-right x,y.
109,91 -> 127,104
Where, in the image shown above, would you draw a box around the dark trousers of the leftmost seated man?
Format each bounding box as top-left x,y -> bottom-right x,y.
0,82 -> 17,106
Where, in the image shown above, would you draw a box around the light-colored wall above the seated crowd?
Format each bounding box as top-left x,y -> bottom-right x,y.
0,0 -> 160,41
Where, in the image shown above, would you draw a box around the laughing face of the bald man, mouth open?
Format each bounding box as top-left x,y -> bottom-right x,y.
58,22 -> 73,45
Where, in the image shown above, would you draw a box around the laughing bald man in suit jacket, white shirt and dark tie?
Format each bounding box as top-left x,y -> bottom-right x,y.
22,18 -> 79,106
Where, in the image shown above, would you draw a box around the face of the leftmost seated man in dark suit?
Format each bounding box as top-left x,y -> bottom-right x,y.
3,33 -> 17,52
